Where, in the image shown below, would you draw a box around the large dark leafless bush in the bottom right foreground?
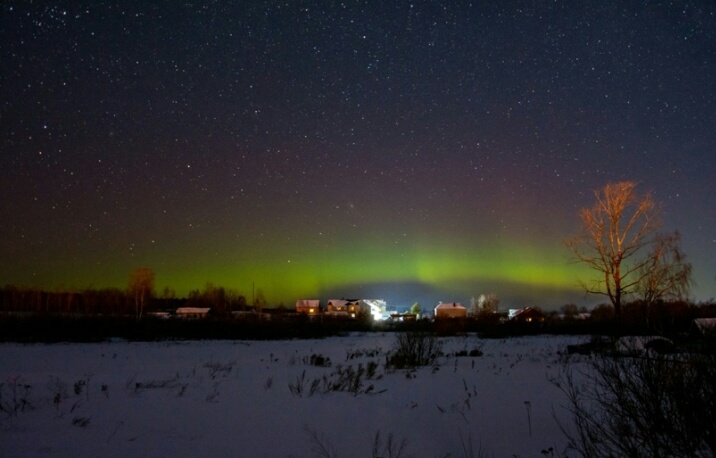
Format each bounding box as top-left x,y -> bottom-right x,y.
556,353 -> 716,457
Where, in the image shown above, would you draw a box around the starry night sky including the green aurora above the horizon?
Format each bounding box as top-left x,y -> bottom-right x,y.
0,0 -> 716,309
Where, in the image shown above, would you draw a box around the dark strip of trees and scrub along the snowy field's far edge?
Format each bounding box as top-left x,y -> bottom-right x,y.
0,286 -> 716,341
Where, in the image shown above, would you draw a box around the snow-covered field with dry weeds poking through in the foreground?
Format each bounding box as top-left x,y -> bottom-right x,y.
0,333 -> 587,458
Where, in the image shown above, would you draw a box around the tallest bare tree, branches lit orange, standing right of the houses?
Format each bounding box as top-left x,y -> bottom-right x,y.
566,181 -> 661,324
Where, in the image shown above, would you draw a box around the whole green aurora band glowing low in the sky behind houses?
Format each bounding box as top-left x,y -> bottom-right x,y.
8,214 -> 589,307
